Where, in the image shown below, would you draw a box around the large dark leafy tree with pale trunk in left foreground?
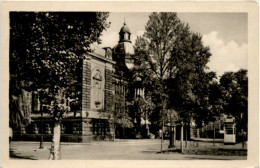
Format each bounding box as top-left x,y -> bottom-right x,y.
10,12 -> 108,159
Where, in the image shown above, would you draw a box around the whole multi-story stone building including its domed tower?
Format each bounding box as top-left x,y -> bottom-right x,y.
10,24 -> 134,142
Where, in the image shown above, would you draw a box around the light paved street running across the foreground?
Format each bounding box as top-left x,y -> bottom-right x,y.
10,139 -> 246,160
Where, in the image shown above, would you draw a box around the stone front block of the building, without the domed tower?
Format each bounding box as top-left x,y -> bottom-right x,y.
14,45 -> 115,142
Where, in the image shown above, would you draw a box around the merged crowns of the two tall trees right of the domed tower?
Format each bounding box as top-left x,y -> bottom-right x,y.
134,12 -> 215,129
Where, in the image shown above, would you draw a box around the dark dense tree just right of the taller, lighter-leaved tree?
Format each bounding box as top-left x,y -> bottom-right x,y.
168,33 -> 216,126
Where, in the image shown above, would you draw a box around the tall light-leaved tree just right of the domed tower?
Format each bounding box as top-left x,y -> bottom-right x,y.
135,12 -> 189,131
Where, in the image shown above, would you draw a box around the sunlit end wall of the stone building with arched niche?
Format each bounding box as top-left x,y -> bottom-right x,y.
79,46 -> 115,142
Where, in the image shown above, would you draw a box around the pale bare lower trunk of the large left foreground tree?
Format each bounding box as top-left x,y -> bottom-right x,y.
49,121 -> 61,160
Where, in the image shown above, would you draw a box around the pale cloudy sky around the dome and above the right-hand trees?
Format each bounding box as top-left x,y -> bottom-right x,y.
100,12 -> 248,76
